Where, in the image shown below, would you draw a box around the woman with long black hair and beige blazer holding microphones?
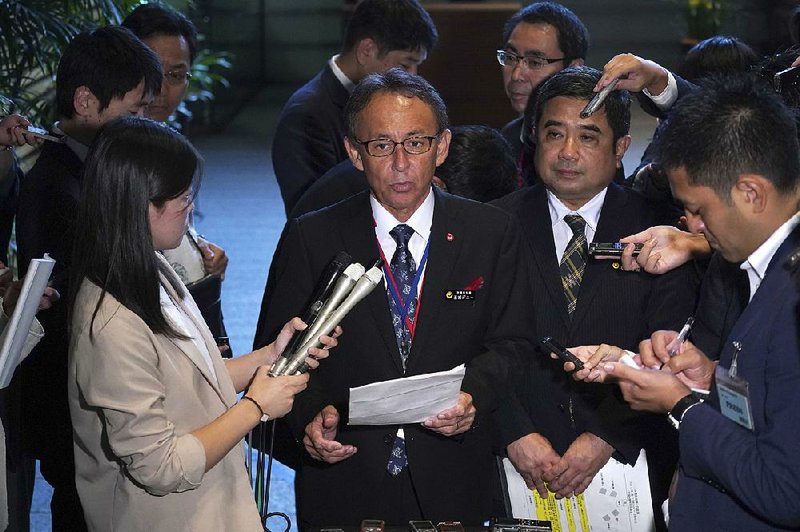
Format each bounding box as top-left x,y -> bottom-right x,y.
69,117 -> 336,532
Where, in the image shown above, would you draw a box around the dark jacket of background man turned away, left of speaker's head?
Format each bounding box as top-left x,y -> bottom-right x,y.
272,64 -> 349,215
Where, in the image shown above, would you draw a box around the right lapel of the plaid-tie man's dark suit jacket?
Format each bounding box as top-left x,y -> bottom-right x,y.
572,183 -> 628,327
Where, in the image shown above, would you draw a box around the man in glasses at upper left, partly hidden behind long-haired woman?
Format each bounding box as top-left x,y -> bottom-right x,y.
122,4 -> 231,348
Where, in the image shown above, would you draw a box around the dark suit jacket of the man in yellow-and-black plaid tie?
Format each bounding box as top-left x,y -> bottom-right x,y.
497,184 -> 695,463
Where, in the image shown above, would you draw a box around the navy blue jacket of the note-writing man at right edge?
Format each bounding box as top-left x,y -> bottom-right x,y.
670,229 -> 800,531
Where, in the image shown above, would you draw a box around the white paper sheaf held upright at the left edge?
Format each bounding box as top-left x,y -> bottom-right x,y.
0,255 -> 54,388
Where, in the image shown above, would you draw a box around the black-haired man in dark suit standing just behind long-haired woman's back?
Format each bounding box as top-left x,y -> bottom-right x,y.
12,26 -> 161,530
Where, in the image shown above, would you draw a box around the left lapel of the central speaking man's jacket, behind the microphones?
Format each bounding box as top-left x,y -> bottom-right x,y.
341,191 -> 403,374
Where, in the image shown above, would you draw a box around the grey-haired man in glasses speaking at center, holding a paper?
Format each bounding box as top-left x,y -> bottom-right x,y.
256,69 -> 532,526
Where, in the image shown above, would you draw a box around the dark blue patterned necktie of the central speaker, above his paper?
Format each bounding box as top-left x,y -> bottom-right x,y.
387,224 -> 417,371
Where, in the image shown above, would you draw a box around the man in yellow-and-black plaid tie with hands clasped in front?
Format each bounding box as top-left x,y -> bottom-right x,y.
497,67 -> 694,528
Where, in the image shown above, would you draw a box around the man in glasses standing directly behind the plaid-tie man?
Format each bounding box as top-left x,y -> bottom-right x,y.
497,2 -> 589,175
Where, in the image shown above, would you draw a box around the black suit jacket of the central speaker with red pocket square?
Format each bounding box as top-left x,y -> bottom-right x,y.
257,187 -> 533,525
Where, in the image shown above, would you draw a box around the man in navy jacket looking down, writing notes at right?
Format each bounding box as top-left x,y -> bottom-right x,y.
607,78 -> 800,531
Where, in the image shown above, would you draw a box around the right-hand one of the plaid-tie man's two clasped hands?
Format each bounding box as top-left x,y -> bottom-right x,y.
543,432 -> 614,499
